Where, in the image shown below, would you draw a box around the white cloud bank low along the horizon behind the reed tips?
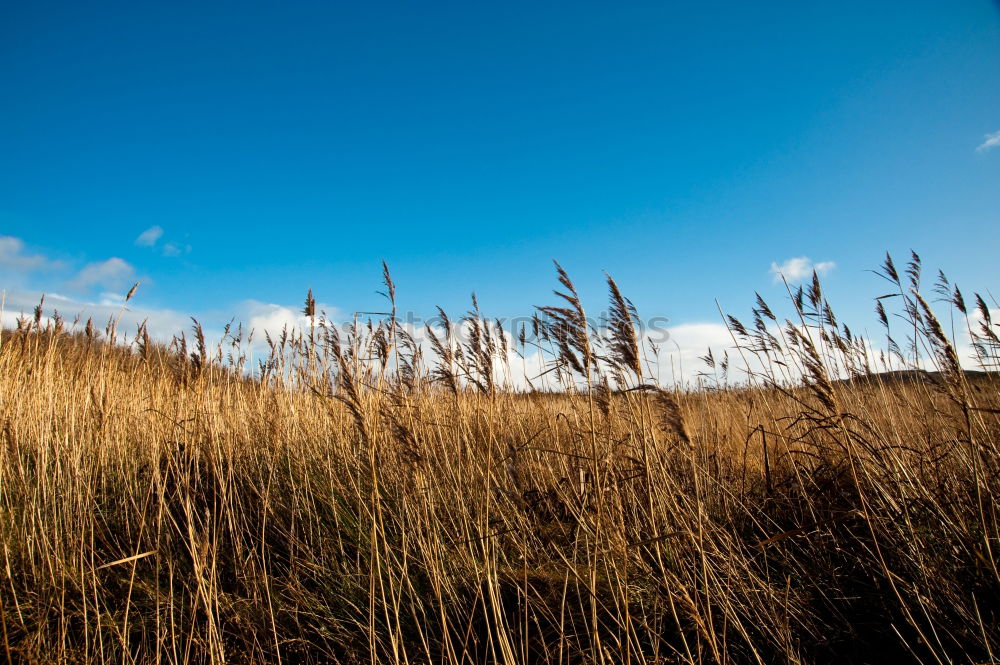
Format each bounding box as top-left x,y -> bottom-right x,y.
0,236 -> 1000,387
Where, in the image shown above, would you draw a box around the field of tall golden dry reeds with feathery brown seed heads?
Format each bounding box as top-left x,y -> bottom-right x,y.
0,252 -> 1000,663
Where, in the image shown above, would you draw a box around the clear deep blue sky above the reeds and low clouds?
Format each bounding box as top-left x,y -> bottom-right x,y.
0,0 -> 1000,344
